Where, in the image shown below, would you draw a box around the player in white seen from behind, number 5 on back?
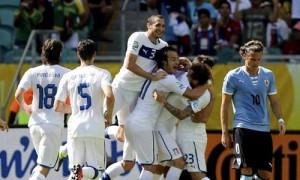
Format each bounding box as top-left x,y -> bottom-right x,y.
55,39 -> 114,180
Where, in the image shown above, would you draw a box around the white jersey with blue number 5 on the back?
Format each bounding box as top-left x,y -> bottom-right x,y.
56,65 -> 111,138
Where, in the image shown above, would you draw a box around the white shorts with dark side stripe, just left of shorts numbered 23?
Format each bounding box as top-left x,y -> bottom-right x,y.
155,131 -> 182,163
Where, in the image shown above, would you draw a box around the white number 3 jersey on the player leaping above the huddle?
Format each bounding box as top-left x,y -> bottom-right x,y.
113,32 -> 168,91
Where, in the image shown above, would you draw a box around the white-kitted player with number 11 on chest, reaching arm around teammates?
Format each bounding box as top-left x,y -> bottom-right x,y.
125,47 -> 207,180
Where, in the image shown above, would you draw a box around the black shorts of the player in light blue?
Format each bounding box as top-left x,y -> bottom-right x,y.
233,128 -> 273,171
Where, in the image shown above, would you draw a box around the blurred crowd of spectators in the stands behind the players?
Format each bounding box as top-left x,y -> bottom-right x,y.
0,0 -> 300,59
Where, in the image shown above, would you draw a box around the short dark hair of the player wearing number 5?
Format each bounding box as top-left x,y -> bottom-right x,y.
77,39 -> 96,61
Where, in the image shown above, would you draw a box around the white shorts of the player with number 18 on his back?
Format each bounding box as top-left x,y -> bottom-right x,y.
29,124 -> 62,168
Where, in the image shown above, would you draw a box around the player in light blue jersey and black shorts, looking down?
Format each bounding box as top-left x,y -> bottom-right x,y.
220,40 -> 285,180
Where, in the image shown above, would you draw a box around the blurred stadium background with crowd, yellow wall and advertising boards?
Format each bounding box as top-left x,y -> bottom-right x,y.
0,0 -> 300,180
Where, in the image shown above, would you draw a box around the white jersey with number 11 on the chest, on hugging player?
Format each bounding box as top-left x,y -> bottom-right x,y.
128,71 -> 188,129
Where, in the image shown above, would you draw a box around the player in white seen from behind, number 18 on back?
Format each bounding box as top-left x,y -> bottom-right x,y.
15,39 -> 69,180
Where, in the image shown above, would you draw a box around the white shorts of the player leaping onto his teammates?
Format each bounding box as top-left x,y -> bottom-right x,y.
113,87 -> 139,124
